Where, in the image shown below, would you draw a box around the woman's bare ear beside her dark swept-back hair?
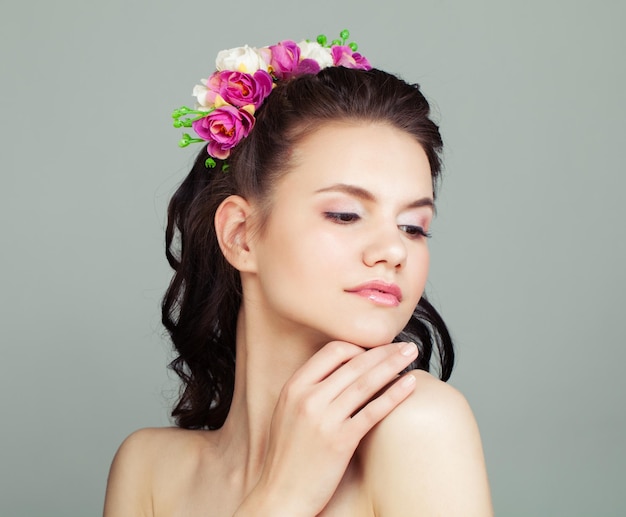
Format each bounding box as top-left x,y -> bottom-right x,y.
214,196 -> 254,272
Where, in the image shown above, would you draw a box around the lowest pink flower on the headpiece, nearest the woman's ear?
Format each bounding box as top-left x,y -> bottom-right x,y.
192,105 -> 254,160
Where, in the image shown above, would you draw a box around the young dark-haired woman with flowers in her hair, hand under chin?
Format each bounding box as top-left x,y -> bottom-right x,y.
104,33 -> 492,517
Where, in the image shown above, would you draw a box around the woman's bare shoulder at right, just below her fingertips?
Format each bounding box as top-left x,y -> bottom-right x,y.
361,370 -> 492,517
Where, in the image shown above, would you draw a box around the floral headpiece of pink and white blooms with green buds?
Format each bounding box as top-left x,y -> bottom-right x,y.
172,30 -> 372,169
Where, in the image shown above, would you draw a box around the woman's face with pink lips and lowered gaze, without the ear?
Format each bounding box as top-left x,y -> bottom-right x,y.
244,122 -> 433,348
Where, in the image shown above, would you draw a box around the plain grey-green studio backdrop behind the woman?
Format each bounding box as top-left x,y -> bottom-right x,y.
0,0 -> 626,517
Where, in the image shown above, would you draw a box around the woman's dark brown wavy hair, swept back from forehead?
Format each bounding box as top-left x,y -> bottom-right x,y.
162,67 -> 454,429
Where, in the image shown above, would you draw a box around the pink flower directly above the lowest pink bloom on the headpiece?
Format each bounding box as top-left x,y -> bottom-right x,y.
203,70 -> 272,108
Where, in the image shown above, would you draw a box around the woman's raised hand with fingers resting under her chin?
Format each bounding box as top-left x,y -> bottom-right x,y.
235,341 -> 417,517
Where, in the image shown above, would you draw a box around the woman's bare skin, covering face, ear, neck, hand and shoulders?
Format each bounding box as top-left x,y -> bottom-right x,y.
104,124 -> 492,517
